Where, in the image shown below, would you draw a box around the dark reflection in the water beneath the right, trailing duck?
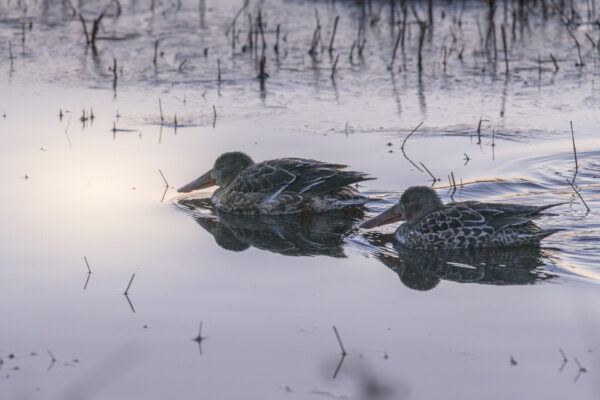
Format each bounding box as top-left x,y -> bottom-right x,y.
363,232 -> 557,291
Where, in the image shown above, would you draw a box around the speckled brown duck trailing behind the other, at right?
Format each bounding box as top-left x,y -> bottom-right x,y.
360,186 -> 564,250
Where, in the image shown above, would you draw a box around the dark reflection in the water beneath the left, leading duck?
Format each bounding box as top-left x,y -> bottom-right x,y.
178,198 -> 364,257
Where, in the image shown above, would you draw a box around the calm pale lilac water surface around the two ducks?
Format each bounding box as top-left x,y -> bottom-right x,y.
0,1 -> 600,399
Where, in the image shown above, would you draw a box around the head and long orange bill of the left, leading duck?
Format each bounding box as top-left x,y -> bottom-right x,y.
177,151 -> 254,193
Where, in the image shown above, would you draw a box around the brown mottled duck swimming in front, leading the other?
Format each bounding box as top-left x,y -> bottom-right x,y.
177,151 -> 374,215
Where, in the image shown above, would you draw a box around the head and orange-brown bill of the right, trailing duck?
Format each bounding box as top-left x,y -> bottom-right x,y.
360,186 -> 444,229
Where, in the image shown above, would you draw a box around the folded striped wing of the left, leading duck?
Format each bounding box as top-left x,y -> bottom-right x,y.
228,158 -> 374,197
